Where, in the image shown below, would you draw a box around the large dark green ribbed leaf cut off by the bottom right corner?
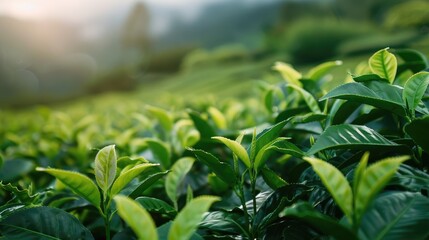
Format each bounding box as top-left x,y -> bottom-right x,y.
359,192 -> 429,240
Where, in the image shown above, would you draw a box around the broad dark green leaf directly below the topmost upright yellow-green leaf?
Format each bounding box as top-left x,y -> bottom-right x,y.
320,82 -> 406,116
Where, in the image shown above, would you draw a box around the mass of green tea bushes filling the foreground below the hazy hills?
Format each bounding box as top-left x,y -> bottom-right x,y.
0,48 -> 429,240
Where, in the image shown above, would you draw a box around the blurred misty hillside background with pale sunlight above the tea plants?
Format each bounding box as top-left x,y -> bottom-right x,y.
0,0 -> 429,108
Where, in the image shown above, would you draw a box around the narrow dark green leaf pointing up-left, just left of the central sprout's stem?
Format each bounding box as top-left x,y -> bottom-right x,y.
188,148 -> 236,186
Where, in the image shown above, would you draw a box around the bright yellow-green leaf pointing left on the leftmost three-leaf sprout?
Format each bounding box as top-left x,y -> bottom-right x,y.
36,168 -> 101,208
